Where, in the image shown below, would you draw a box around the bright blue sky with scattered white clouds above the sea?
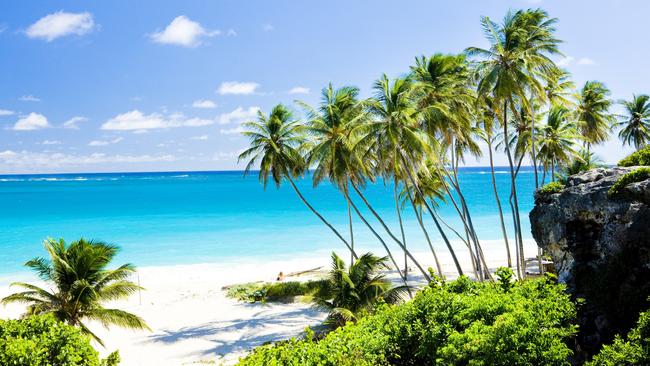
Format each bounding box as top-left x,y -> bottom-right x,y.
0,0 -> 650,174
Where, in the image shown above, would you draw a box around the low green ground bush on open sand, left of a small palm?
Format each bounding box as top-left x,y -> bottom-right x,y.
226,280 -> 328,303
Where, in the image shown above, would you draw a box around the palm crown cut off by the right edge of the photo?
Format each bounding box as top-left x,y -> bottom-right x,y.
616,94 -> 650,150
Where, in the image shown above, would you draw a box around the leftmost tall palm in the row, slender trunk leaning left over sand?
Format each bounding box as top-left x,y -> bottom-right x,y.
239,104 -> 357,258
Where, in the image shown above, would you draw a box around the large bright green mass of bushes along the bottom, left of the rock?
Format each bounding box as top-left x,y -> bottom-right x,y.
239,272 -> 576,365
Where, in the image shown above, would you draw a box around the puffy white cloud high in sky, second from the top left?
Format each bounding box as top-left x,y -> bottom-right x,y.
151,15 -> 221,47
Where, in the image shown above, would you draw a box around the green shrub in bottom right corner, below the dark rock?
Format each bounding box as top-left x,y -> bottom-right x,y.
587,311 -> 650,366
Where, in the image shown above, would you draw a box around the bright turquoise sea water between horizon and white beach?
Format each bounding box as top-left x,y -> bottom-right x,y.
0,168 -> 533,274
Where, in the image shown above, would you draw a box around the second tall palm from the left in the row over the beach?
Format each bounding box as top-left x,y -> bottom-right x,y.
298,84 -> 365,261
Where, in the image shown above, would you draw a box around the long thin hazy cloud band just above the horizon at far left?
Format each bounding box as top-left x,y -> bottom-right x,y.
0,150 -> 177,170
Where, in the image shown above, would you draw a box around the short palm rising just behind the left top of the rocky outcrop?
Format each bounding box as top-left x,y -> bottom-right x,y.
539,106 -> 579,181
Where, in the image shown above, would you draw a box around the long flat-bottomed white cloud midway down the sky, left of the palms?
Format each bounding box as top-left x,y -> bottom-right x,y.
101,109 -> 215,132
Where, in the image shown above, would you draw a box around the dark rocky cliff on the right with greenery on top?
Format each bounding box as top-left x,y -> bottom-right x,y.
530,167 -> 650,354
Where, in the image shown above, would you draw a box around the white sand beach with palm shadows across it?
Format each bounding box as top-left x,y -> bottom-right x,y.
0,242 -> 536,366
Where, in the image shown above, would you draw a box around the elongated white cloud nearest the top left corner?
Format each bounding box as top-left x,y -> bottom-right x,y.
26,11 -> 95,42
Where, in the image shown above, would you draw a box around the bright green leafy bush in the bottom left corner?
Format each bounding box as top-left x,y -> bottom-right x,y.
0,315 -> 119,366
